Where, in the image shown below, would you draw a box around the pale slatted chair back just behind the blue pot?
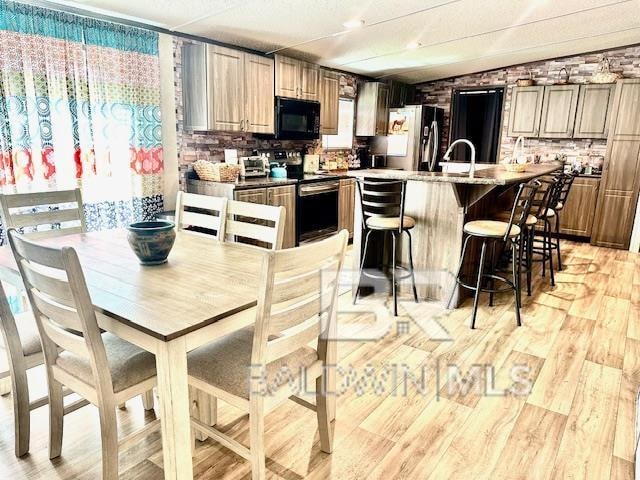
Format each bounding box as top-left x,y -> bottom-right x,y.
175,191 -> 227,238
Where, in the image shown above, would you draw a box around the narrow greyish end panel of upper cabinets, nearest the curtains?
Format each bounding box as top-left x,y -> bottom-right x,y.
182,43 -> 209,130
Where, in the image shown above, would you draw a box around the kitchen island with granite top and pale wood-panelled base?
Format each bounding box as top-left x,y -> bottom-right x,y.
349,162 -> 561,307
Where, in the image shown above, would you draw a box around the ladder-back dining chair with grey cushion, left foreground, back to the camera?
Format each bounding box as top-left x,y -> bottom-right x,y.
8,229 -> 160,479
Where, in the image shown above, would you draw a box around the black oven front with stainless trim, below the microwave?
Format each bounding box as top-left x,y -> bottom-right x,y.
296,179 -> 340,244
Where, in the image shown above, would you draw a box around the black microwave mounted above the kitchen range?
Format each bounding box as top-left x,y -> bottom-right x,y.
276,97 -> 320,140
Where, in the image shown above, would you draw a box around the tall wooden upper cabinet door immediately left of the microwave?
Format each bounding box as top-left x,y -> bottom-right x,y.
244,53 -> 275,133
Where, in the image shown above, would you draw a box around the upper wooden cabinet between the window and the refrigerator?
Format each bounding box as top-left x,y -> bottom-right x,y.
356,82 -> 389,137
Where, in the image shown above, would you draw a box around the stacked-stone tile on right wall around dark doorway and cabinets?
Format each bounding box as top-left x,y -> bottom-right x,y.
417,45 -> 640,167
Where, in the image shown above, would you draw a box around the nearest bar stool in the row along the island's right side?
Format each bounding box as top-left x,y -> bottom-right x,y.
449,181 -> 540,329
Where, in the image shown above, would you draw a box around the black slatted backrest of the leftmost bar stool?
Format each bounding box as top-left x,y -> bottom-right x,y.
357,178 -> 407,231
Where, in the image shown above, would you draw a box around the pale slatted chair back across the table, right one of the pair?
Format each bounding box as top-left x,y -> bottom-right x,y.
224,200 -> 286,250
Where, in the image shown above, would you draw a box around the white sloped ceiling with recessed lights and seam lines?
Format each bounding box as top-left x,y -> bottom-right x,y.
33,0 -> 640,83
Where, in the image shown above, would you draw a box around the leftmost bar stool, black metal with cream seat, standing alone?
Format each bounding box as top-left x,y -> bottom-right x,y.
353,178 -> 418,317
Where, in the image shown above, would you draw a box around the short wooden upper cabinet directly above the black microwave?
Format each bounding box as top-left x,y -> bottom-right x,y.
275,55 -> 320,101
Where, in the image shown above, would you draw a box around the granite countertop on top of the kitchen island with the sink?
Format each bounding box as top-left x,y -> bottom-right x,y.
348,162 -> 562,185
